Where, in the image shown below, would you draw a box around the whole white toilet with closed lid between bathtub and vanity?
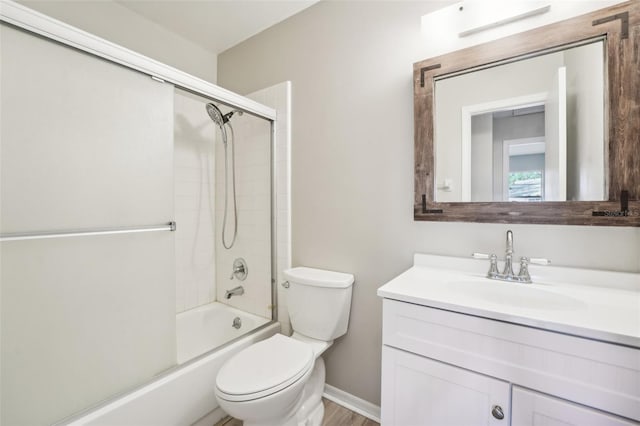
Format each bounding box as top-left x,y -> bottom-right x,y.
215,267 -> 354,426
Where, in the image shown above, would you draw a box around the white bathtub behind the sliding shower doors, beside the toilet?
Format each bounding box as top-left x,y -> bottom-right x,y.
63,302 -> 280,426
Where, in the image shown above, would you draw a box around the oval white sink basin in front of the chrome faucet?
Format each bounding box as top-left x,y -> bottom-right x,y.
444,279 -> 586,310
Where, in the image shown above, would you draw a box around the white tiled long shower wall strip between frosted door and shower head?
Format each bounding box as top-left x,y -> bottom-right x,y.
174,90 -> 219,312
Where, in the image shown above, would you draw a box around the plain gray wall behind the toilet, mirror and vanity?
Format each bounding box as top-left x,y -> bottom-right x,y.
218,1 -> 640,404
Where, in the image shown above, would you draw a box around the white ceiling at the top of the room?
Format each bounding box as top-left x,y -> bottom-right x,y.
115,0 -> 318,54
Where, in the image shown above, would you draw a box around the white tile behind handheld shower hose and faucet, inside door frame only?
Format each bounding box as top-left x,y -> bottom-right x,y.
215,109 -> 271,318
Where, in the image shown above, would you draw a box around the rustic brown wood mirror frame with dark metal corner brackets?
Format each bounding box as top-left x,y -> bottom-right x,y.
413,0 -> 640,226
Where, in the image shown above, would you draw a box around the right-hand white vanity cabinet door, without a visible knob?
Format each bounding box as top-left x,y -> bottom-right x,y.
511,386 -> 638,426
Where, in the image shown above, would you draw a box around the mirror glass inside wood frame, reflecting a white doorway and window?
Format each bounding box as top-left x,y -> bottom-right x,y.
434,40 -> 607,202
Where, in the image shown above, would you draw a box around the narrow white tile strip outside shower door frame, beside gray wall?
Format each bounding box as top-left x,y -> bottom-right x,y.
247,81 -> 291,335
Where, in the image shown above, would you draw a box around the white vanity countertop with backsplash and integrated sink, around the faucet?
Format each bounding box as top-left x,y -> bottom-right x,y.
378,254 -> 640,348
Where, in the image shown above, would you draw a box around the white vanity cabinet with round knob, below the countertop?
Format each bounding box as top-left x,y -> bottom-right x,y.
381,298 -> 640,426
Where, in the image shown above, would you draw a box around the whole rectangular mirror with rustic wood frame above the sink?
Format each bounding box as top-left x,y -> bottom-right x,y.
414,1 -> 640,226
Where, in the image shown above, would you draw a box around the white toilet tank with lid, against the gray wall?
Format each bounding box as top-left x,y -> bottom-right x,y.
284,267 -> 354,342
